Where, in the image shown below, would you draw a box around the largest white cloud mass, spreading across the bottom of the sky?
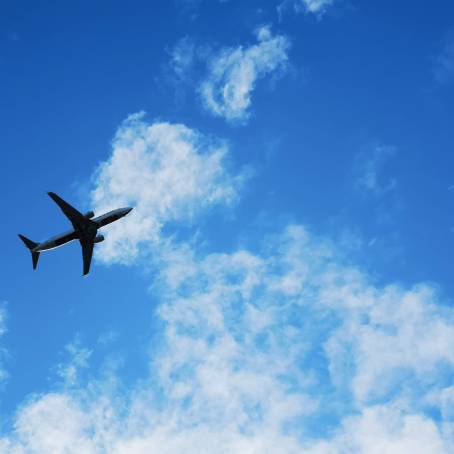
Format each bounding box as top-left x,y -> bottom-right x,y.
0,225 -> 454,454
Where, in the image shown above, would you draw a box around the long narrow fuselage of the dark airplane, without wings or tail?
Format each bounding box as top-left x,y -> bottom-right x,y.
33,207 -> 132,252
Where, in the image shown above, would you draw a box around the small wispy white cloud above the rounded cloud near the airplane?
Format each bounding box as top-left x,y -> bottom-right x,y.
200,27 -> 290,121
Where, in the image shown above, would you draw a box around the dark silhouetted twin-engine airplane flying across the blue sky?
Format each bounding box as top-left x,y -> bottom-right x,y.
19,192 -> 132,276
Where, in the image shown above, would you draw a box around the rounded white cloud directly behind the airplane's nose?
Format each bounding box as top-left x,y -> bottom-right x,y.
92,113 -> 241,263
